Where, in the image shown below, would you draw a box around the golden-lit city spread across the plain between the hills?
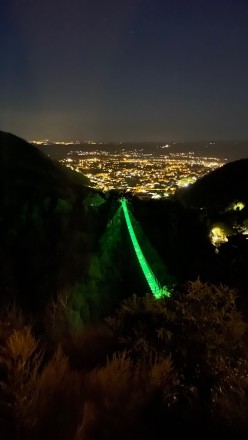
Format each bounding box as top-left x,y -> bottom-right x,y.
57,147 -> 226,198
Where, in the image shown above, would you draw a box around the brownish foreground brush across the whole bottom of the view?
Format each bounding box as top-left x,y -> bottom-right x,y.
0,279 -> 248,440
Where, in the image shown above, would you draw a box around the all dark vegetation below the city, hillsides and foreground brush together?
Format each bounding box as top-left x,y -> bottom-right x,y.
0,133 -> 248,440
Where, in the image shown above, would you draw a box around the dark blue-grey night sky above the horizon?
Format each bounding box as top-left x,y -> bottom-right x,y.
0,0 -> 248,141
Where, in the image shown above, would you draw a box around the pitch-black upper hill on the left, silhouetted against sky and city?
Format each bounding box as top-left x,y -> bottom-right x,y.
0,131 -> 91,201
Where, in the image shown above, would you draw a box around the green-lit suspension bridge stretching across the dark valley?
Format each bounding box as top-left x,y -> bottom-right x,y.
121,198 -> 170,298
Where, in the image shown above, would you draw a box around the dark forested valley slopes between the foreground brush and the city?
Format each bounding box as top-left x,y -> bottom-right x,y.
0,132 -> 248,321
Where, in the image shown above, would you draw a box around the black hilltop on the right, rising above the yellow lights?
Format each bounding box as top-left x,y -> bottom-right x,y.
177,159 -> 248,209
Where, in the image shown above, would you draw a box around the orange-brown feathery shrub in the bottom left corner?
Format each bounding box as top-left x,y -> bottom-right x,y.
0,327 -> 76,438
